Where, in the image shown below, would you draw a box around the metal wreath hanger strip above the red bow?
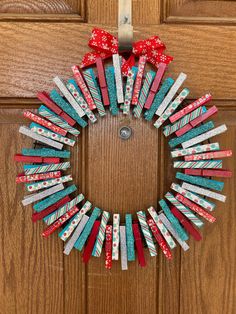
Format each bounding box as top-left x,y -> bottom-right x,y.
118,0 -> 133,52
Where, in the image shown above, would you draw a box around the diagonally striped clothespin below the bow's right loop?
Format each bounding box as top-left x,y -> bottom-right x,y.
133,71 -> 155,118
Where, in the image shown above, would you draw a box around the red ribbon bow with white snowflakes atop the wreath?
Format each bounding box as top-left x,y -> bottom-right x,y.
81,28 -> 173,74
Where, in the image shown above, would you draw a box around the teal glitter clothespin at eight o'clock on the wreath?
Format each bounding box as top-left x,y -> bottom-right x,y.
33,184 -> 77,212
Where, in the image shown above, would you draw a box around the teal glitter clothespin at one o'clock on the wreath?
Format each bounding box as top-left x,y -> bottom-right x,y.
144,77 -> 175,121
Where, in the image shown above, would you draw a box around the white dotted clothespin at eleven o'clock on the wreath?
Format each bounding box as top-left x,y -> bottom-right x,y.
66,79 -> 97,123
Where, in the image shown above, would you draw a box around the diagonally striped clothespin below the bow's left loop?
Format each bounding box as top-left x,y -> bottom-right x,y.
84,69 -> 106,117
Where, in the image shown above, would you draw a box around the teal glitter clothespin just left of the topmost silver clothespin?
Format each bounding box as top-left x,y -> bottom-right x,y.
105,66 -> 119,116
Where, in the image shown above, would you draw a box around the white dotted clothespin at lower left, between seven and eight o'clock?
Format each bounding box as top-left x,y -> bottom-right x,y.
59,201 -> 92,241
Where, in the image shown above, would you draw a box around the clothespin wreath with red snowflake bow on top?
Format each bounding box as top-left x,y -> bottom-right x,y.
15,28 -> 232,270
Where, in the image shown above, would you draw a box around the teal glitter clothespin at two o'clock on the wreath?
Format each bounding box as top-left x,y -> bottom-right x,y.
168,121 -> 214,148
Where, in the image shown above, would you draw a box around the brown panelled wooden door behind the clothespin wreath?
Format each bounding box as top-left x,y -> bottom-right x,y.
0,0 -> 236,314
